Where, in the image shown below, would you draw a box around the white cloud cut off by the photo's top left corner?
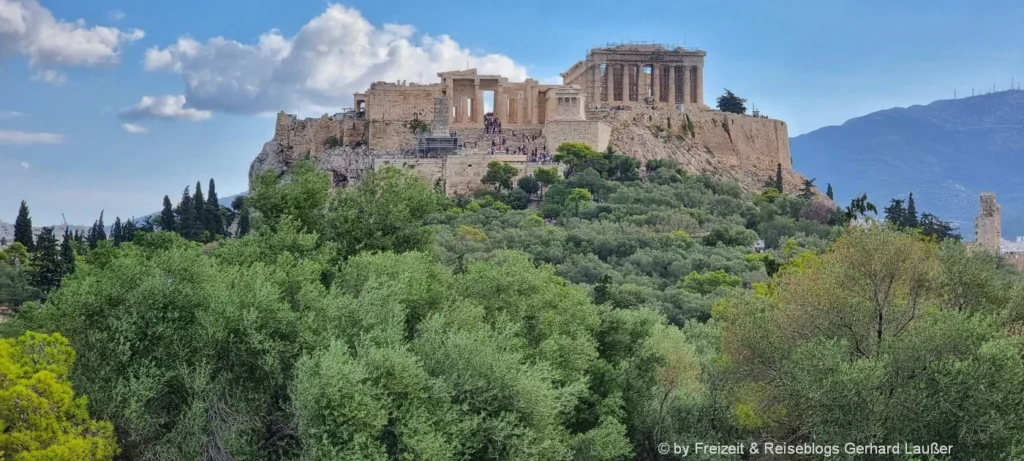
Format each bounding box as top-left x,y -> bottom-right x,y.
0,0 -> 145,67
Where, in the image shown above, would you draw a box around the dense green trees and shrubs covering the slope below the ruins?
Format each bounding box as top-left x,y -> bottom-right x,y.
0,144 -> 1024,460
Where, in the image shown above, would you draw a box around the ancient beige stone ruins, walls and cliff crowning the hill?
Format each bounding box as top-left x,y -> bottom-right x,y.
250,44 -> 800,194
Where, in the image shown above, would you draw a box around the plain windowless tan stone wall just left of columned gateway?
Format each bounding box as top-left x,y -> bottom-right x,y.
367,83 -> 442,123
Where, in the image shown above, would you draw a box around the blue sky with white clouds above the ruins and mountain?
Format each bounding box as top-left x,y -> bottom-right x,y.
0,0 -> 1024,225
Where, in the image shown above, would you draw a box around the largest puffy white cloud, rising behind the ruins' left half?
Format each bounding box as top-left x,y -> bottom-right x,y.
144,4 -> 526,114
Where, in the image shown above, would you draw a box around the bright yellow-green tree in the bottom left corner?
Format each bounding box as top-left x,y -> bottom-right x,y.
0,333 -> 120,461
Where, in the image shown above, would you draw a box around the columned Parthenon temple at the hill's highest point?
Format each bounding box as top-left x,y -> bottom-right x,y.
562,44 -> 708,108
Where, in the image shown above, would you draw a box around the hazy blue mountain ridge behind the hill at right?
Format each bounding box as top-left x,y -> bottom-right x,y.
790,90 -> 1024,240
